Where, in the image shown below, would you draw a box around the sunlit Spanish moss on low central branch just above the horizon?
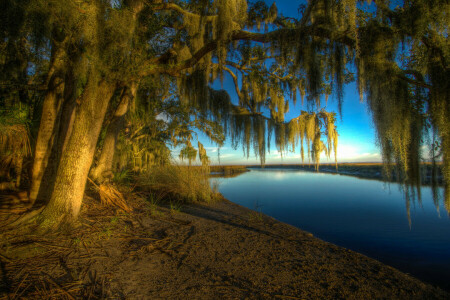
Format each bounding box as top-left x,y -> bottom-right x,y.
179,64 -> 338,169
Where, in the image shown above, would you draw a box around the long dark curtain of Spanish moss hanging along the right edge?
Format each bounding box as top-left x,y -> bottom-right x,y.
356,1 -> 450,216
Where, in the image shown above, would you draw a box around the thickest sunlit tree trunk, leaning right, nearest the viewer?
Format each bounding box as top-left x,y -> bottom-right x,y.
41,75 -> 115,227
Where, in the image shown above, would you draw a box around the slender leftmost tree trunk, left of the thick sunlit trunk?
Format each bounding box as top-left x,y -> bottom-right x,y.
29,48 -> 65,204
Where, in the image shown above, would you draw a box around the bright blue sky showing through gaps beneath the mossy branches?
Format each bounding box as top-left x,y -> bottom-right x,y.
173,0 -> 381,165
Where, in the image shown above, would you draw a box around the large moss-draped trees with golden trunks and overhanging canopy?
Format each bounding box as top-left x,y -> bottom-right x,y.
2,0 -> 450,226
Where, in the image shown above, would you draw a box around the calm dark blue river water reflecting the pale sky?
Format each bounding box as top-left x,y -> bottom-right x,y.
214,169 -> 450,289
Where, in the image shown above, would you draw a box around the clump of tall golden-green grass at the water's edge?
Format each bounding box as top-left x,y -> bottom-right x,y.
138,165 -> 218,203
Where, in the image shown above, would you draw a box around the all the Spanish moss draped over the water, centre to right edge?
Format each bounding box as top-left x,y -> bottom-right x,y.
163,0 -> 450,213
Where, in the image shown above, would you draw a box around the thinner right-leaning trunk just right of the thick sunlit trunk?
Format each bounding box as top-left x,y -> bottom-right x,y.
91,84 -> 136,183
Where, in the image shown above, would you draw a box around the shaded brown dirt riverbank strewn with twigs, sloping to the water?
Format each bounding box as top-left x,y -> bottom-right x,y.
0,193 -> 450,299
